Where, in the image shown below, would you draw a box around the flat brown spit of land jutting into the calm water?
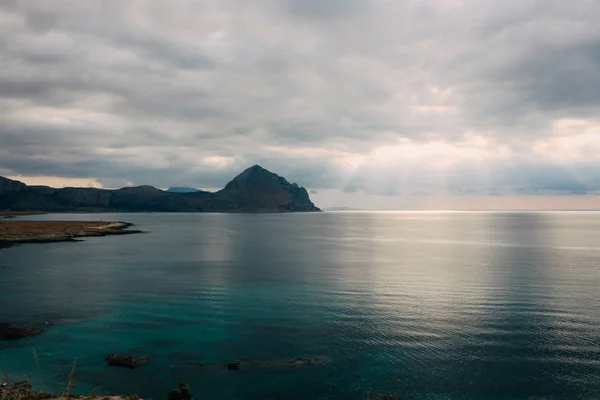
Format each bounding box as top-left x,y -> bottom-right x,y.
0,220 -> 141,245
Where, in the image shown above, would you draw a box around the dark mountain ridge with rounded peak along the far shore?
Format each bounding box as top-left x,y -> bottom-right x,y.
0,165 -> 321,212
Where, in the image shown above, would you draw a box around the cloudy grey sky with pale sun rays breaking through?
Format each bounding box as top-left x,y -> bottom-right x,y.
0,0 -> 600,209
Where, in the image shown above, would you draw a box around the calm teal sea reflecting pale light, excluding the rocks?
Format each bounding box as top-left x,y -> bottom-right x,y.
0,213 -> 600,400
